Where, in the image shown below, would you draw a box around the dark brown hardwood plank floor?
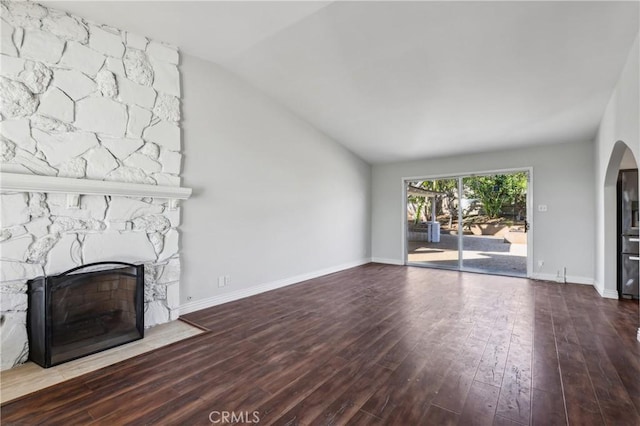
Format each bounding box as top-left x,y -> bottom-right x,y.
1,264 -> 640,425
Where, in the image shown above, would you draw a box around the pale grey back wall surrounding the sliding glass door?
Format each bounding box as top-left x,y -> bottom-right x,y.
371,142 -> 594,283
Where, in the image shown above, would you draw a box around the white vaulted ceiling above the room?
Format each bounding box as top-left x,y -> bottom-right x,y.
46,1 -> 639,163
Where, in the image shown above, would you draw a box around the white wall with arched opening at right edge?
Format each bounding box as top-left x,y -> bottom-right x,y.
595,38 -> 640,298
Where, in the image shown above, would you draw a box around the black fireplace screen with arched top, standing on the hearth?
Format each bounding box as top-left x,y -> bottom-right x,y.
27,262 -> 144,368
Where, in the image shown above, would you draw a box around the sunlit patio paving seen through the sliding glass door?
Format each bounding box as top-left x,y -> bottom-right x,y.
408,234 -> 527,276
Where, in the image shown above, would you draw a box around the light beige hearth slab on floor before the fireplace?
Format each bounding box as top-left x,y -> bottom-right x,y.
0,320 -> 203,403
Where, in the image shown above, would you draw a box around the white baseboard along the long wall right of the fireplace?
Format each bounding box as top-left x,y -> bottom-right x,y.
180,258 -> 371,315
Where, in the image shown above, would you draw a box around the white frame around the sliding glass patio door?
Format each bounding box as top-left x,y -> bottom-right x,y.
400,166 -> 535,278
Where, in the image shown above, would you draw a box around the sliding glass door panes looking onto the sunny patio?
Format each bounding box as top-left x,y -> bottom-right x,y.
405,171 -> 529,276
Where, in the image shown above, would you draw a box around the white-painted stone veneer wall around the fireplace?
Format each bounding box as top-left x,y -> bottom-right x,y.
0,1 -> 182,369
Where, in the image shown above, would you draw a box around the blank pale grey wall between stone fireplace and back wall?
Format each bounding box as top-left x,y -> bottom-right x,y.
181,55 -> 371,312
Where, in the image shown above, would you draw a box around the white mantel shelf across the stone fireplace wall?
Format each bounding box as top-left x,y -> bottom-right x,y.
0,173 -> 192,206
